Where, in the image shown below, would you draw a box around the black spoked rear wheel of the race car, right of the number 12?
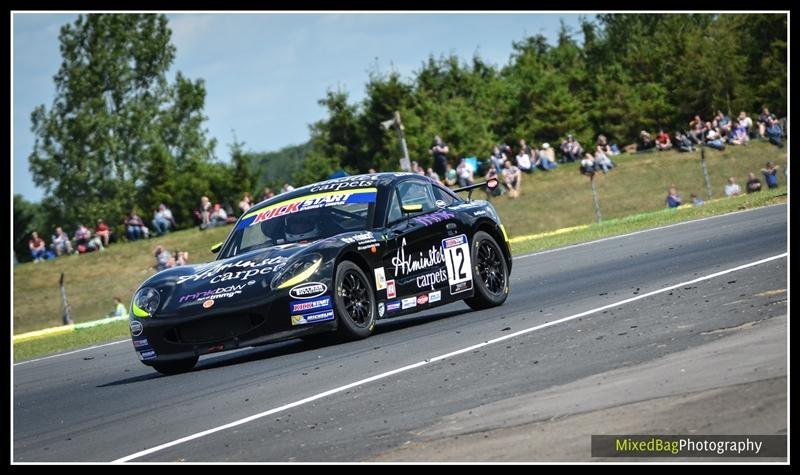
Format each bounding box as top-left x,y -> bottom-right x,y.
464,231 -> 508,310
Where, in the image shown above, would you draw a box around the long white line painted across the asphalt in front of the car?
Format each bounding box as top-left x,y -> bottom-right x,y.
112,252 -> 788,463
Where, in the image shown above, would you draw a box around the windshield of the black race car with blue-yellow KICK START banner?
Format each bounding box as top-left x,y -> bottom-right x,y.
220,188 -> 377,258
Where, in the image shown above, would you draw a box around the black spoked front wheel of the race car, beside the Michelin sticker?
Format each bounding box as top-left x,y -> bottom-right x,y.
335,261 -> 376,340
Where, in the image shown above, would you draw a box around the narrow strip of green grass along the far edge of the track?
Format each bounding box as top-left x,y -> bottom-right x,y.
14,187 -> 787,361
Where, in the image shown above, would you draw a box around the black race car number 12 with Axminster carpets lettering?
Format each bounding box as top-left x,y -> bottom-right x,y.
130,173 -> 511,374
